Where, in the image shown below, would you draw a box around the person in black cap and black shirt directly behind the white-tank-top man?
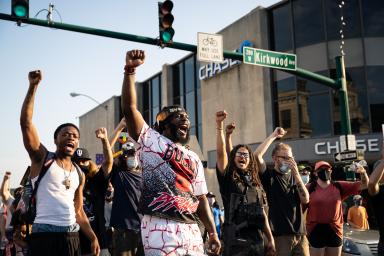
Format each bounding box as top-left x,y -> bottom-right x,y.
72,128 -> 112,256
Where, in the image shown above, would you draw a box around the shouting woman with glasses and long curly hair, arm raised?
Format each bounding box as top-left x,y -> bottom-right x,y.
216,110 -> 275,256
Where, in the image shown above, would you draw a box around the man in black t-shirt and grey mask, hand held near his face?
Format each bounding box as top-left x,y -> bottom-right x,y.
255,131 -> 309,256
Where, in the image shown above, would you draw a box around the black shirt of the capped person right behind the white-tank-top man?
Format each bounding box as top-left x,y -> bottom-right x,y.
80,169 -> 108,253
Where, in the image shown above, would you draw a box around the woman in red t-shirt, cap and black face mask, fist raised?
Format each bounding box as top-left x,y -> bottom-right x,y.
307,161 -> 368,256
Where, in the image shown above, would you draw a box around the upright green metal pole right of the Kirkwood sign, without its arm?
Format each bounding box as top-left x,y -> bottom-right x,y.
335,56 -> 352,135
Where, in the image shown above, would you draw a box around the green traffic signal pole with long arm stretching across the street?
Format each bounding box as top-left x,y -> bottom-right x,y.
0,13 -> 351,134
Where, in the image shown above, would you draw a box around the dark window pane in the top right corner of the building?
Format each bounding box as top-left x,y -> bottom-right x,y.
361,0 -> 384,37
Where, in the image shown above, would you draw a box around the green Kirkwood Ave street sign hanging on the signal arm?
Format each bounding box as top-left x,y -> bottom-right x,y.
243,47 -> 296,70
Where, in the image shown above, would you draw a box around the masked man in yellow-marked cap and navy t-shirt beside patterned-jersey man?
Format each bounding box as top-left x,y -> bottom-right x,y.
104,141 -> 144,255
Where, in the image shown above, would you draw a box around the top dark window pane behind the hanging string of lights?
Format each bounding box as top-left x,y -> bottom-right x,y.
325,0 -> 361,41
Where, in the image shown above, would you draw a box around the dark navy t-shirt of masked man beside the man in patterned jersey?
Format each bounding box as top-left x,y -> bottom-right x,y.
110,164 -> 143,231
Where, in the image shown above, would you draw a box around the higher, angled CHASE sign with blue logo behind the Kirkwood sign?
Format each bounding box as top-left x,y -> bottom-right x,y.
199,40 -> 253,80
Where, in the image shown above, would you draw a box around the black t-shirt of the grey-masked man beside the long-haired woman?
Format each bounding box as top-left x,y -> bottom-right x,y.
261,169 -> 305,236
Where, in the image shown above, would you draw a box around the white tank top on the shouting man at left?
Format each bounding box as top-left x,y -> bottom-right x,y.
32,161 -> 80,226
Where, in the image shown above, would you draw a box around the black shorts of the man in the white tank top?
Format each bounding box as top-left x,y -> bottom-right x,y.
28,232 -> 80,256
